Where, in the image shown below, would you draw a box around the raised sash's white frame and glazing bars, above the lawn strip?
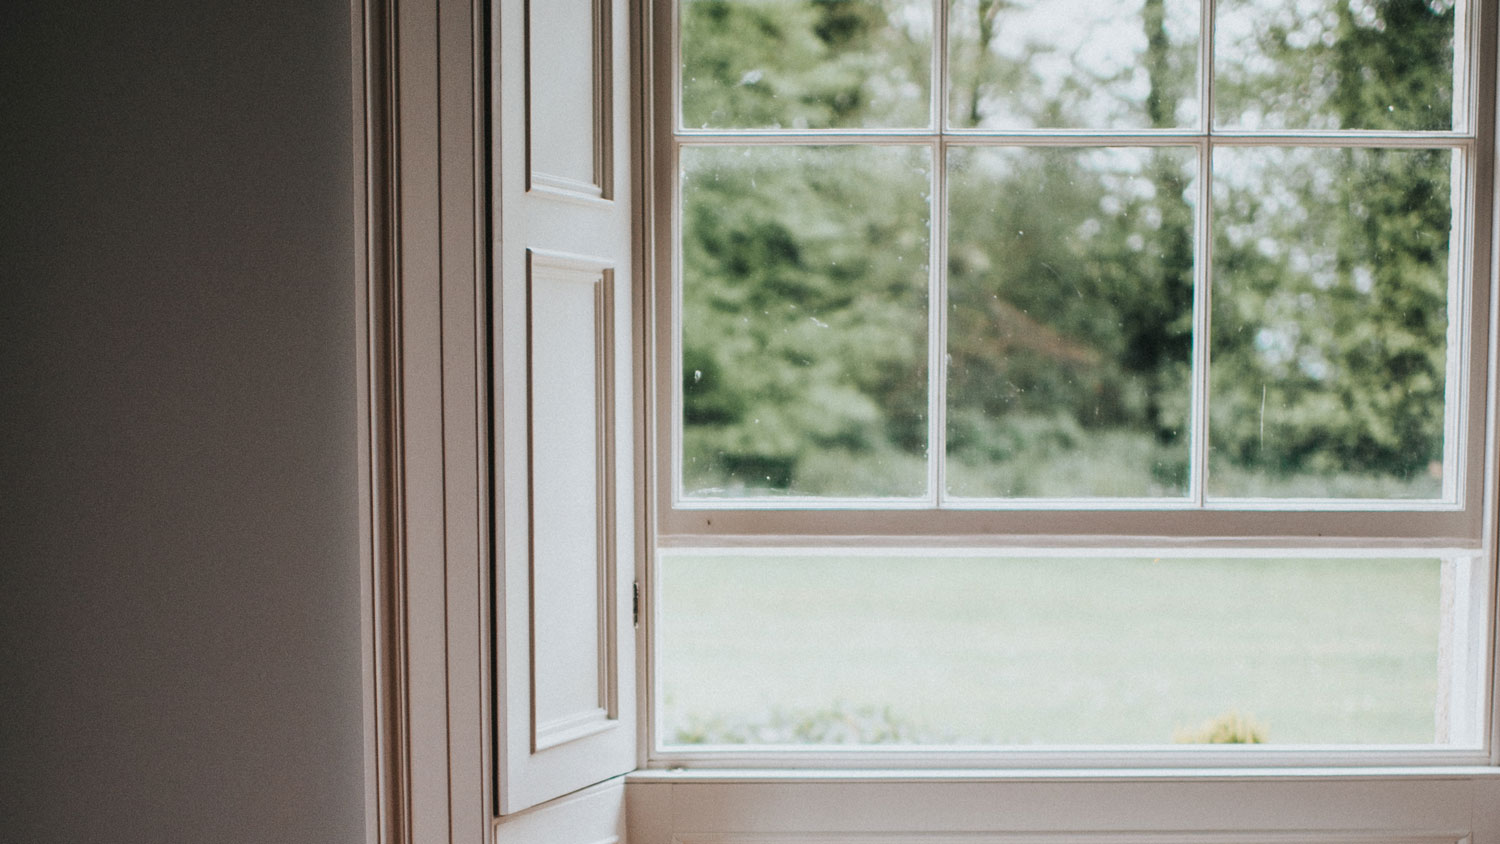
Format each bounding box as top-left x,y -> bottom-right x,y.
651,0 -> 1494,549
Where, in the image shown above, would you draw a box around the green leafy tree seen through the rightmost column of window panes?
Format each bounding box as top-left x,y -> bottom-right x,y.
1211,0 -> 1454,496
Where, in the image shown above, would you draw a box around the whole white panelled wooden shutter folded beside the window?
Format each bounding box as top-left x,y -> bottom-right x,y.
492,0 -> 636,814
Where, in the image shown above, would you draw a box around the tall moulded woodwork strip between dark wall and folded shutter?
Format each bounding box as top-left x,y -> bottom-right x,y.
354,0 -> 494,844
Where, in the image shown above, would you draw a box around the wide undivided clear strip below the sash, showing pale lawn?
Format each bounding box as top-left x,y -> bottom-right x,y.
656,553 -> 1463,745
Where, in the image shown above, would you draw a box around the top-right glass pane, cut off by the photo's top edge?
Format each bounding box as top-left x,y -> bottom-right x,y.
1214,0 -> 1463,130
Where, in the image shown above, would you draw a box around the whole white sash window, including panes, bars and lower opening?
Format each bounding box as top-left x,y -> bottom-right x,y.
651,0 -> 1493,765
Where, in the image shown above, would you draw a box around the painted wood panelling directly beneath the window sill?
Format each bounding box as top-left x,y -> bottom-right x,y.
627,769 -> 1500,844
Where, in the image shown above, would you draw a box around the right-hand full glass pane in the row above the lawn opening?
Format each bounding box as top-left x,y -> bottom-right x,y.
1208,147 -> 1454,498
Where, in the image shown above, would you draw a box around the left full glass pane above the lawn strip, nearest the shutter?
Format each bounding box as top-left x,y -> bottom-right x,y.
681,147 -> 932,498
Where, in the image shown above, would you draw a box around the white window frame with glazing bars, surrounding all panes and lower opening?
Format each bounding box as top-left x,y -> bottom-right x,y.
641,0 -> 1497,771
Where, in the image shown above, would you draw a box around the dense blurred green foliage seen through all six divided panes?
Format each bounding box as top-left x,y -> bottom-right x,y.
681,0 -> 1454,496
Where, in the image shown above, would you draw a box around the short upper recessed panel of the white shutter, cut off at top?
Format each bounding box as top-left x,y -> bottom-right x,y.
525,0 -> 612,196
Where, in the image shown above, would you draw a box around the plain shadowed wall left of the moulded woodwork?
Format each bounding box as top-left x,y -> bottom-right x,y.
0,0 -> 363,844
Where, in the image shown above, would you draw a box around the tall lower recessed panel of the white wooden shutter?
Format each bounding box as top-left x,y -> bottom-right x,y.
527,253 -> 614,750
